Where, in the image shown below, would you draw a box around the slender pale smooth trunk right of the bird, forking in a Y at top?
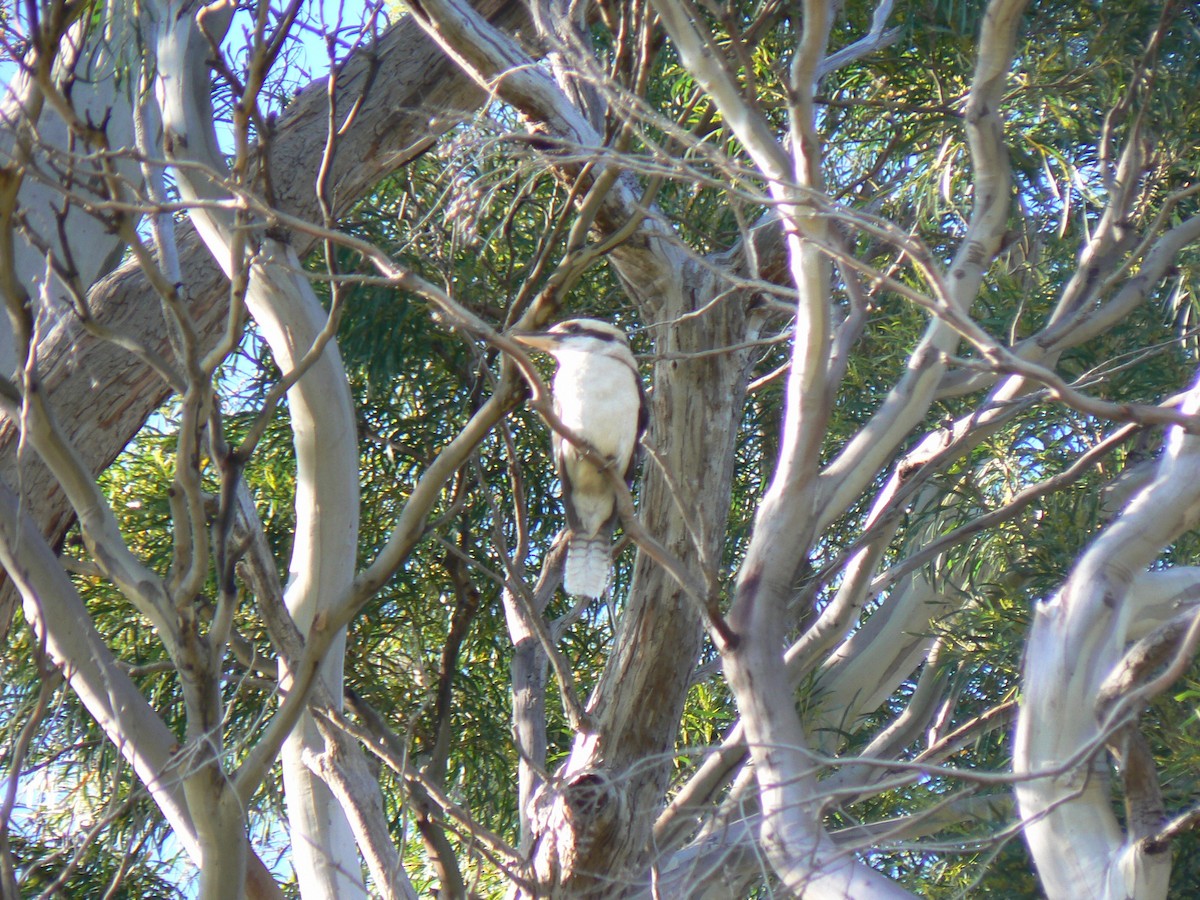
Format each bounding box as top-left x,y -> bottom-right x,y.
655,0 -> 905,898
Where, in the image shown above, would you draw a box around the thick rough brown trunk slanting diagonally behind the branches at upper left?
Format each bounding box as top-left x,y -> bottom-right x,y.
0,0 -> 524,637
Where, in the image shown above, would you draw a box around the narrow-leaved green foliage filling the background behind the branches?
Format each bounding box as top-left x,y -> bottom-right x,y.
7,0 -> 1200,898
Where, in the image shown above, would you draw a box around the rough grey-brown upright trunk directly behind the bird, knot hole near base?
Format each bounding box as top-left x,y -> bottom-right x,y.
533,259 -> 749,898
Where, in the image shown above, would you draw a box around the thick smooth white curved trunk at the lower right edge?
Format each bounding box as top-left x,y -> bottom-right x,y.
1013,372 -> 1200,900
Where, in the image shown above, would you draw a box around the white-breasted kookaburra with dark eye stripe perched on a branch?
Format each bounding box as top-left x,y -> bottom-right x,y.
516,319 -> 647,598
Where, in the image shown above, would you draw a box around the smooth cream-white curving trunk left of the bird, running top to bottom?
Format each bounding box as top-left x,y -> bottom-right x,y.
148,4 -> 366,899
